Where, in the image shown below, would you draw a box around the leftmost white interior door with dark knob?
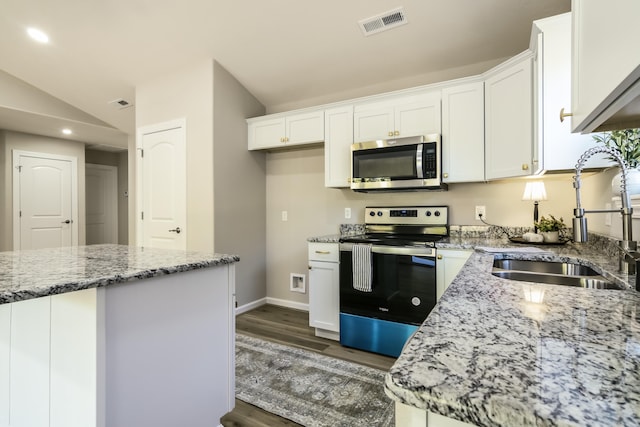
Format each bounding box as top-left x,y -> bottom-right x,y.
13,150 -> 78,250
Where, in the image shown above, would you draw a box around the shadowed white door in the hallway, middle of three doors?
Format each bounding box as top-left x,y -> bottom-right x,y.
85,163 -> 118,245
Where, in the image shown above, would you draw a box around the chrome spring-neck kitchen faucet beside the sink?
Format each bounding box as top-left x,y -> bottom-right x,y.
573,147 -> 640,274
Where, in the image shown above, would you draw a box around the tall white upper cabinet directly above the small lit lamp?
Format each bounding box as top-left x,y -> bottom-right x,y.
531,13 -> 610,173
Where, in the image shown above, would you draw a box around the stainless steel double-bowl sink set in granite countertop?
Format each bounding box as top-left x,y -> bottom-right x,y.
491,259 -> 622,289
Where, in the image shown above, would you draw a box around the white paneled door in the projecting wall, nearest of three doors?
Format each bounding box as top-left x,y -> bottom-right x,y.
137,120 -> 187,249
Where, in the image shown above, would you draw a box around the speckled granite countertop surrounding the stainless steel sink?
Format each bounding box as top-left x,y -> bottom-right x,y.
385,238 -> 640,427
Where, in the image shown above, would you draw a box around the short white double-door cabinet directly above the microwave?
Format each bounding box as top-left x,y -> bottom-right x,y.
353,91 -> 441,142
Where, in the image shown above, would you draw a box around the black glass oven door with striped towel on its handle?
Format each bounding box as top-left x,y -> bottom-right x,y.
340,243 -> 436,325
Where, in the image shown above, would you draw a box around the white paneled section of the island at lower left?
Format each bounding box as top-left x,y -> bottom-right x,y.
0,289 -> 97,427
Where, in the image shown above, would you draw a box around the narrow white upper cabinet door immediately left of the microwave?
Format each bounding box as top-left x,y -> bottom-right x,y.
324,105 -> 353,188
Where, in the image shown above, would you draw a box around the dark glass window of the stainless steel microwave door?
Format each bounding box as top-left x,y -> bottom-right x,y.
353,145 -> 417,179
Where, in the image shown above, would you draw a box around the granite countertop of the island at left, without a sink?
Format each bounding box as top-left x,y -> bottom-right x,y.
0,245 -> 240,304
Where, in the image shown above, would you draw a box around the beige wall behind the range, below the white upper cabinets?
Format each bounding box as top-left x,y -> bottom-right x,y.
267,148 -> 624,304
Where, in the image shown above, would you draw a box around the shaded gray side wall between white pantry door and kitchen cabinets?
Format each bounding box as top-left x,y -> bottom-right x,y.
213,62 -> 267,306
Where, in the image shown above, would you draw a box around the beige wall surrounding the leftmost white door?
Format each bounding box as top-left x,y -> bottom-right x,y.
0,131 -> 86,251
